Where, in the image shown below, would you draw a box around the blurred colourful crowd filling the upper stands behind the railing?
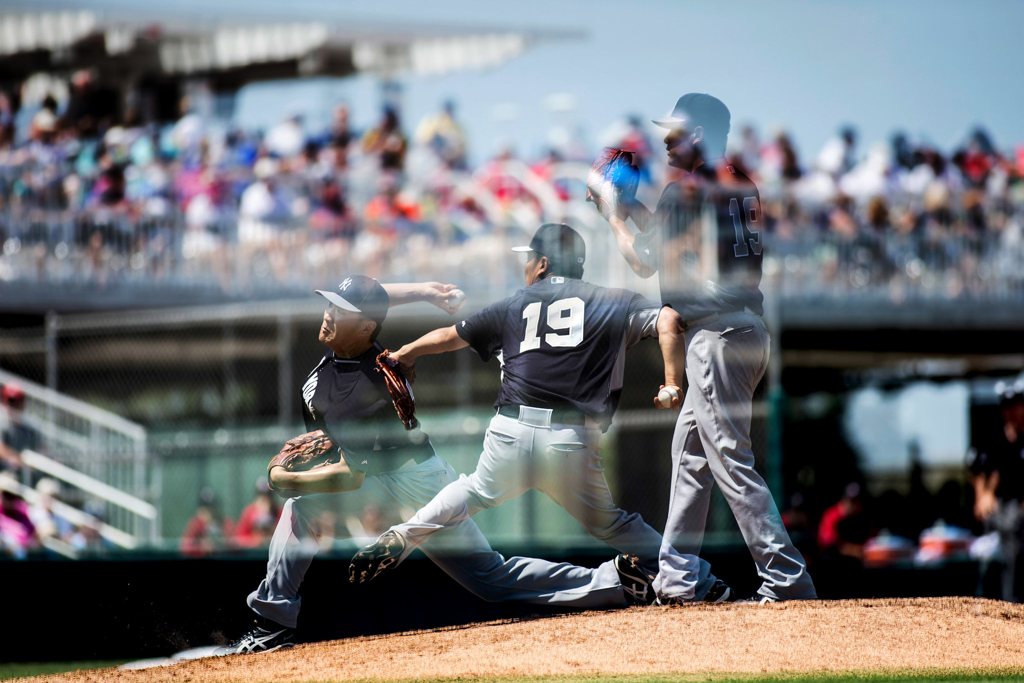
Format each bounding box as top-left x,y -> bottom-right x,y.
0,72 -> 1024,295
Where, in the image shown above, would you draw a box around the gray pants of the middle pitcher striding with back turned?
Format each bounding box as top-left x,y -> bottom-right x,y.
392,407 -> 715,590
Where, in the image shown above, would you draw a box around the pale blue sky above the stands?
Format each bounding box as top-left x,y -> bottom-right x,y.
232,0 -> 1024,160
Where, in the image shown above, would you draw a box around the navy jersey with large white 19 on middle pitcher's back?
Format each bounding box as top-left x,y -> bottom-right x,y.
456,276 -> 662,426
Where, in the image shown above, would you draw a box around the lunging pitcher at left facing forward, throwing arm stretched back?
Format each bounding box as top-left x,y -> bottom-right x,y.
219,275 -> 651,654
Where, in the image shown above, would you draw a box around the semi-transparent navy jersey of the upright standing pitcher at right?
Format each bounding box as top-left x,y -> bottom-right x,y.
633,166 -> 764,322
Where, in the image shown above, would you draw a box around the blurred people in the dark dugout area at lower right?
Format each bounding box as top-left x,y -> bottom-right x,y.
782,375 -> 1024,602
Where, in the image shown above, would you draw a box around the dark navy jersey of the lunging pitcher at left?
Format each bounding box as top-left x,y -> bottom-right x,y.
302,344 -> 434,474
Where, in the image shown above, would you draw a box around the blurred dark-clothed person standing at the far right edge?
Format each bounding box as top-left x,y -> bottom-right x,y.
970,376 -> 1024,602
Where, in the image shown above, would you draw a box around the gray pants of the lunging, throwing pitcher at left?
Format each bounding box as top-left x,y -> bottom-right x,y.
247,456 -> 626,628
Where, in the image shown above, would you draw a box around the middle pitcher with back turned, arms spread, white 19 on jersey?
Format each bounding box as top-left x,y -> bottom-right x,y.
350,223 -> 729,603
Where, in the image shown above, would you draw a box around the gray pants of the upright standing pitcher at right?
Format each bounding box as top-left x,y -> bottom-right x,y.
654,312 -> 816,600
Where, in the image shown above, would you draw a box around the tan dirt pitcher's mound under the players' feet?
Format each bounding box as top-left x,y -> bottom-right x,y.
22,598 -> 1024,683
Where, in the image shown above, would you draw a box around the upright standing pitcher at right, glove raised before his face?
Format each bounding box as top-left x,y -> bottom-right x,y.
588,93 -> 815,602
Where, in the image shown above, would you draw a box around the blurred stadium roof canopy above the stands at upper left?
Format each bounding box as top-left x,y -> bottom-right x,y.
0,0 -> 582,90
